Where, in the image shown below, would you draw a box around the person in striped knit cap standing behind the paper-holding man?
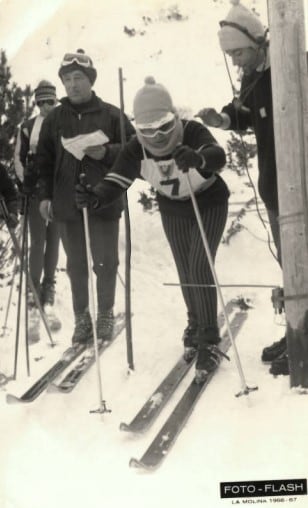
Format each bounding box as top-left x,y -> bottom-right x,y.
14,80 -> 61,343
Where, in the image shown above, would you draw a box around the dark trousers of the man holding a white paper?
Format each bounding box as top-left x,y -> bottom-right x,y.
60,216 -> 119,314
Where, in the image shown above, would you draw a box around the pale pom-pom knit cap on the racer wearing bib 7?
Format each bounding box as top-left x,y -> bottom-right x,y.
133,76 -> 175,129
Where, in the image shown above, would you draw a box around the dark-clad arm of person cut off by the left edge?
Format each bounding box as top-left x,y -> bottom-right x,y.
0,163 -> 18,229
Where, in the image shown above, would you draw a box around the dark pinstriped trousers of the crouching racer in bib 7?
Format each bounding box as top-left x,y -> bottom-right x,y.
162,202 -> 228,328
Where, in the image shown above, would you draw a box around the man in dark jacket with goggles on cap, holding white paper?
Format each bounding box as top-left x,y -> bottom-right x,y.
37,50 -> 134,343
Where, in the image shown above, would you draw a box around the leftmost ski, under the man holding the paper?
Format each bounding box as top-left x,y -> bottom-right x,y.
6,344 -> 86,404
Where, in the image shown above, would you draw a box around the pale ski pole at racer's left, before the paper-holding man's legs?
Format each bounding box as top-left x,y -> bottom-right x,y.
82,206 -> 110,413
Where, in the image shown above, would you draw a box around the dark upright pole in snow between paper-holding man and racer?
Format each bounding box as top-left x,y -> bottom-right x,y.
119,67 -> 134,371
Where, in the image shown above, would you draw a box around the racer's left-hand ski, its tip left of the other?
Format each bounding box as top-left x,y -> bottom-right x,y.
120,300 -> 237,433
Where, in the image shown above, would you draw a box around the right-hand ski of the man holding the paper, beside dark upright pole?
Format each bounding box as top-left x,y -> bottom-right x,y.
48,314 -> 125,393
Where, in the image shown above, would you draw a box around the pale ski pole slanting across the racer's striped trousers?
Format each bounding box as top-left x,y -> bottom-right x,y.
185,173 -> 258,397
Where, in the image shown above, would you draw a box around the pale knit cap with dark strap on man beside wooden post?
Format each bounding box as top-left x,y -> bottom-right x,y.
218,0 -> 265,51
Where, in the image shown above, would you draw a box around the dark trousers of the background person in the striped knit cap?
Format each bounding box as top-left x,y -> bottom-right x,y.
29,196 -> 60,291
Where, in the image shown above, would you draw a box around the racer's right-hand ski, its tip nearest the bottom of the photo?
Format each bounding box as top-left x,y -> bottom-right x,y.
129,311 -> 247,471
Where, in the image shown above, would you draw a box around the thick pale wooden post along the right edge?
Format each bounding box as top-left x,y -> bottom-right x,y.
268,0 -> 308,389
